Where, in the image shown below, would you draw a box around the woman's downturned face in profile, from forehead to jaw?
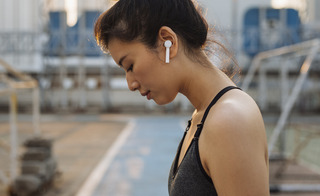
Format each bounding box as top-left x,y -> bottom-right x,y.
108,38 -> 179,105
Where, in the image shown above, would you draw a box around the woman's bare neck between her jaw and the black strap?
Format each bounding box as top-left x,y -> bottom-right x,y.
180,59 -> 234,112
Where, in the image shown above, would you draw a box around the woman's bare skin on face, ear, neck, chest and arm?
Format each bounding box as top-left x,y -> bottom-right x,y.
108,27 -> 269,196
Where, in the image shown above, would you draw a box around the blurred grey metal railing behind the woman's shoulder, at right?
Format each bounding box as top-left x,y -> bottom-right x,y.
241,39 -> 320,153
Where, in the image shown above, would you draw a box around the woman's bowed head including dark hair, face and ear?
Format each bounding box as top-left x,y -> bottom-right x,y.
94,0 -> 208,105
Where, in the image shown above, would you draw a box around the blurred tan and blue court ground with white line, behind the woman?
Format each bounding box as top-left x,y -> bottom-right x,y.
0,114 -> 320,196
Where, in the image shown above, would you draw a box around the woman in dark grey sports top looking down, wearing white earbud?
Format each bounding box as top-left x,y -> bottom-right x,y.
95,0 -> 269,196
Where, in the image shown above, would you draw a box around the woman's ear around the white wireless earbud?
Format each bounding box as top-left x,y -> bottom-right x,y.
158,26 -> 179,59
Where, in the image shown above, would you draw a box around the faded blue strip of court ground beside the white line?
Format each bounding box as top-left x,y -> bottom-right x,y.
82,116 -> 188,196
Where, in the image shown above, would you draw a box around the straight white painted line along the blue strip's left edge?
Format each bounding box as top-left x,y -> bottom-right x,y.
76,120 -> 135,196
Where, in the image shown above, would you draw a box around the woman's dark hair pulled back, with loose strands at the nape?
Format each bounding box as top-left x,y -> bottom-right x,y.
94,0 -> 237,79
